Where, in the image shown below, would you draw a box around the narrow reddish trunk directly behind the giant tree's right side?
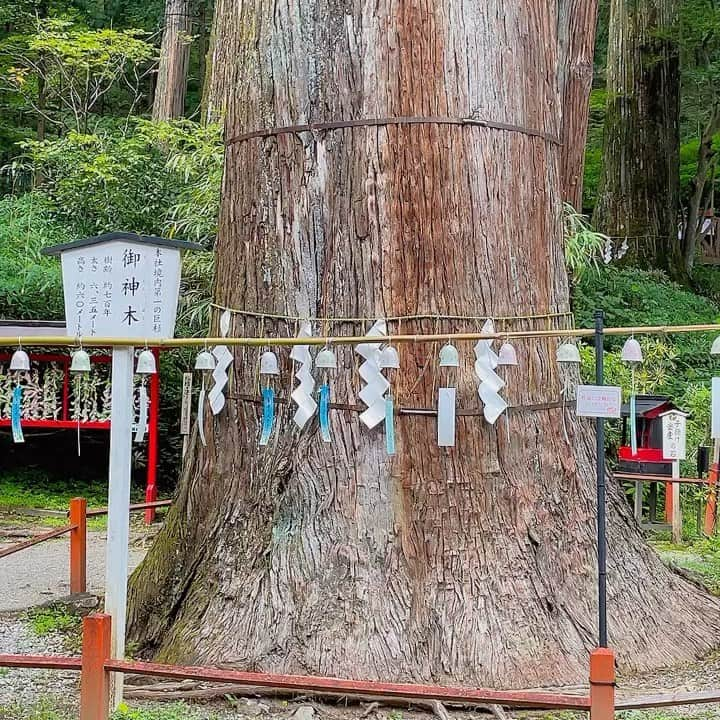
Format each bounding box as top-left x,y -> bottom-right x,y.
558,0 -> 598,212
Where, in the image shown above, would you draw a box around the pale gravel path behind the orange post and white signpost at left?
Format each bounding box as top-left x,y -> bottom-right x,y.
0,531 -> 145,612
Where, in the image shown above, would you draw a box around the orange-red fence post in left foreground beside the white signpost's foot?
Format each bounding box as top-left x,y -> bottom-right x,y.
80,613 -> 111,720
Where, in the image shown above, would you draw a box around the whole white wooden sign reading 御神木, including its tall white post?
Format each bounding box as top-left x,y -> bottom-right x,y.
45,233 -> 200,707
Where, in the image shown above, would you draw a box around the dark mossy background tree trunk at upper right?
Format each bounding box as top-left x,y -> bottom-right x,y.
593,0 -> 685,279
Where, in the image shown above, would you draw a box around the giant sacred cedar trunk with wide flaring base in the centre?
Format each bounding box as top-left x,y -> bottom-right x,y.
129,0 -> 720,687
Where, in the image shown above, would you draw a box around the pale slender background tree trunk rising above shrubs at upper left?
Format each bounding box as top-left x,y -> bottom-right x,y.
152,0 -> 192,120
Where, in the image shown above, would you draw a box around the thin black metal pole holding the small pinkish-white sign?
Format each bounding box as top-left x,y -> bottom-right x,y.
595,310 -> 607,647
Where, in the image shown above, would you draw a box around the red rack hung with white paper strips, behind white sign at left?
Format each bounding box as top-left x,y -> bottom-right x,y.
0,320 -> 160,523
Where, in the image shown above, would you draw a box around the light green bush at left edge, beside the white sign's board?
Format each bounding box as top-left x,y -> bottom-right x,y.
0,193 -> 65,320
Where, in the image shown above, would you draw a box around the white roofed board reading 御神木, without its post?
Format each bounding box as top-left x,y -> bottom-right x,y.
42,233 -> 198,341
